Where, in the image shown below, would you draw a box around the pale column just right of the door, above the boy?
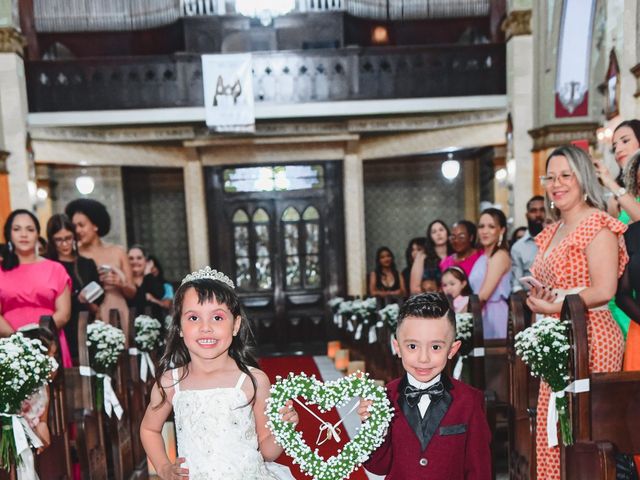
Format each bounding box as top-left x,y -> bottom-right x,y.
343,146 -> 367,295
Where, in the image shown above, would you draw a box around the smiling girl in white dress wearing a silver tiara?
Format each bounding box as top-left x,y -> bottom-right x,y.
140,267 -> 298,480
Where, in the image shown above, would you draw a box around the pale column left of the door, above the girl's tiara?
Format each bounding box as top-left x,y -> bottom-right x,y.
184,156 -> 210,271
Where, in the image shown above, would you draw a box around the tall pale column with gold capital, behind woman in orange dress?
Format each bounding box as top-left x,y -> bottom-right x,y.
507,10 -> 534,225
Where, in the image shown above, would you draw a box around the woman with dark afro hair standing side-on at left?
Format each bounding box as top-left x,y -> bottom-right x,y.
65,198 -> 136,338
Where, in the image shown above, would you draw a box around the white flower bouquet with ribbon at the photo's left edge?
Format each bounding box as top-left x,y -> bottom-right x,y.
0,333 -> 58,470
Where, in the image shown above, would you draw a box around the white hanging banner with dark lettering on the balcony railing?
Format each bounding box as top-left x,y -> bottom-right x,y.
202,54 -> 255,132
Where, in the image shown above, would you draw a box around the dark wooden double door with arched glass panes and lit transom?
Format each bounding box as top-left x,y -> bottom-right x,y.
207,162 -> 344,354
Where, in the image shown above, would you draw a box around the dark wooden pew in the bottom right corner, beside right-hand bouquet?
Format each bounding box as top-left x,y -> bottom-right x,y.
561,295 -> 640,480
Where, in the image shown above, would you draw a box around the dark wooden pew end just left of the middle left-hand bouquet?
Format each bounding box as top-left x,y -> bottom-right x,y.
65,312 -> 108,480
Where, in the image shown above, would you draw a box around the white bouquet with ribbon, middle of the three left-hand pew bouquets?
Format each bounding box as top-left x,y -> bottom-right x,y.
87,320 -> 125,418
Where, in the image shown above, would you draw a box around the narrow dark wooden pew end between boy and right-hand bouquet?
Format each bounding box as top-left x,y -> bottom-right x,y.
507,291 -> 540,480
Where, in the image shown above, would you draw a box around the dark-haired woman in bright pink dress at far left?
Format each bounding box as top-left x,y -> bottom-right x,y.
0,210 -> 72,367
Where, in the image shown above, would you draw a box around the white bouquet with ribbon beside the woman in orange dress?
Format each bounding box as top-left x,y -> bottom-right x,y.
515,317 -> 573,445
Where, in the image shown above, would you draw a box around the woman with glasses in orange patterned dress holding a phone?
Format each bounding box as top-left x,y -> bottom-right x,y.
527,146 -> 628,480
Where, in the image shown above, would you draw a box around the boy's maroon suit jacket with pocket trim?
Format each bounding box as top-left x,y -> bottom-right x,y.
364,374 -> 492,480
